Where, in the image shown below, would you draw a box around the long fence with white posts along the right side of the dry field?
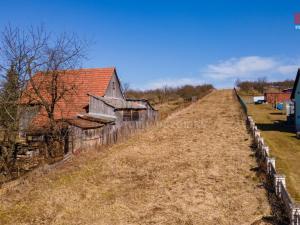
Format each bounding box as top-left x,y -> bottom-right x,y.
234,89 -> 300,225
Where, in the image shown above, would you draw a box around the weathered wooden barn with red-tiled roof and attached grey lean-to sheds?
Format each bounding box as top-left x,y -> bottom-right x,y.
20,68 -> 158,154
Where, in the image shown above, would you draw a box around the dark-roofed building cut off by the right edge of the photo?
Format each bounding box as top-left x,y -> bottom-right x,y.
291,69 -> 300,132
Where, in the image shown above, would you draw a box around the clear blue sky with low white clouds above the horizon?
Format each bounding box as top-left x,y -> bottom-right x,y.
0,0 -> 300,89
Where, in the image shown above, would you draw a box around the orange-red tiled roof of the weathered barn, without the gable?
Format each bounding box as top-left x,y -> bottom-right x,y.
21,68 -> 115,125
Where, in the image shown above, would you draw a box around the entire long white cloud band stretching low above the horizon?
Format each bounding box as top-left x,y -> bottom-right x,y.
139,56 -> 300,90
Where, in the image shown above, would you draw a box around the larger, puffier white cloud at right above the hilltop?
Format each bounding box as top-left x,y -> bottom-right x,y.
202,56 -> 300,81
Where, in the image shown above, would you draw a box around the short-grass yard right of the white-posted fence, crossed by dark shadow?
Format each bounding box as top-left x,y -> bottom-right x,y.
248,104 -> 300,202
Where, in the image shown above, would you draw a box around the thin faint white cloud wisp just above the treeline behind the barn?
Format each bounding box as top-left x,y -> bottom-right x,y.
144,78 -> 204,89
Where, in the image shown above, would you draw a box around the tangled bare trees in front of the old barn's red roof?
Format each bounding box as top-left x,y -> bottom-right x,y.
0,26 -> 86,176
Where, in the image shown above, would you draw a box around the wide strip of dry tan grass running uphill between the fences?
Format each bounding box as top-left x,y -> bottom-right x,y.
0,90 -> 270,225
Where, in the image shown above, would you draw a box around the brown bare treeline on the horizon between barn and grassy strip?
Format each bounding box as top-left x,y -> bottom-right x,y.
125,84 -> 214,104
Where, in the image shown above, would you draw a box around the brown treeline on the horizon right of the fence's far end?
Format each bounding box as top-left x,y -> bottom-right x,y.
235,78 -> 294,94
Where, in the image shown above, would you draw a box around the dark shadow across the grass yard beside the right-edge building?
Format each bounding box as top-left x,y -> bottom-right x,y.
256,120 -> 295,133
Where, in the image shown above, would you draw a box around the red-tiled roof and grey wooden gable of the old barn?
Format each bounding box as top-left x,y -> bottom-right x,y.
21,68 -> 124,127
